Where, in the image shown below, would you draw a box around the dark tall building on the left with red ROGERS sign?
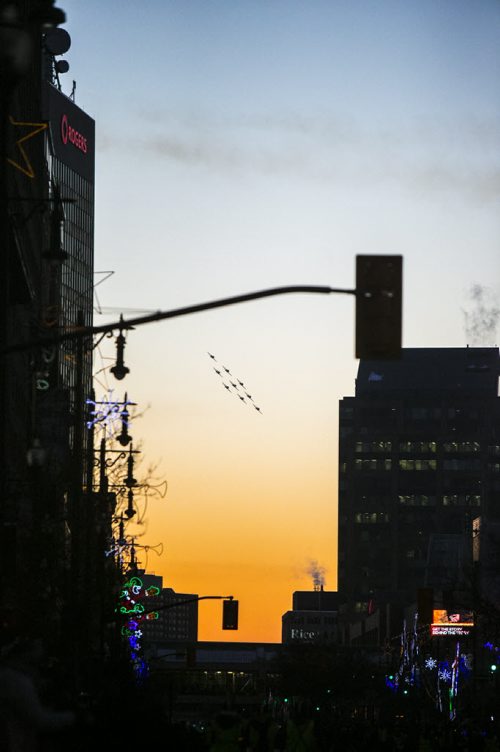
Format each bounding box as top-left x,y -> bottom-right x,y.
0,5 -> 96,672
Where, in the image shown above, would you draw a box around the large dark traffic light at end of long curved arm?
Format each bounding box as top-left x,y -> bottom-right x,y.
355,256 -> 403,360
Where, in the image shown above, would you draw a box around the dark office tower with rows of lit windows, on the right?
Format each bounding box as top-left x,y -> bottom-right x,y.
338,347 -> 500,633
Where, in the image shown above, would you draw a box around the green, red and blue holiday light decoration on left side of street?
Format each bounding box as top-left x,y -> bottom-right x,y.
117,576 -> 160,681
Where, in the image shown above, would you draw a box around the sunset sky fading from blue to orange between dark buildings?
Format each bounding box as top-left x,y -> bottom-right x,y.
57,0 -> 500,642
